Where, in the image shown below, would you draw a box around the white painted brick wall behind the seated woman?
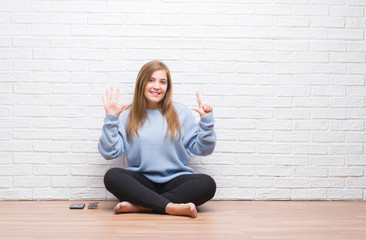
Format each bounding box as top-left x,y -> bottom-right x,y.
0,0 -> 366,200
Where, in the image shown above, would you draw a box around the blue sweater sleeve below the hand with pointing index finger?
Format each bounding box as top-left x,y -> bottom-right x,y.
184,112 -> 216,156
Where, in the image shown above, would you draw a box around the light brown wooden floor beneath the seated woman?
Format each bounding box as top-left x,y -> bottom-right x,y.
0,201 -> 366,240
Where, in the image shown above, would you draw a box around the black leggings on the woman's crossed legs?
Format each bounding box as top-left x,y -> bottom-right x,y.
104,168 -> 216,213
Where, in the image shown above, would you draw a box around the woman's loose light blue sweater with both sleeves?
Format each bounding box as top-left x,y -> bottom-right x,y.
98,104 -> 216,183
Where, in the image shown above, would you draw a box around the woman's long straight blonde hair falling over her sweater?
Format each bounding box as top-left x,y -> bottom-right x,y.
126,60 -> 181,140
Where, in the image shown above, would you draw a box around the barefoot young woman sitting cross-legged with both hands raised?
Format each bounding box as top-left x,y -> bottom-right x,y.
98,61 -> 216,218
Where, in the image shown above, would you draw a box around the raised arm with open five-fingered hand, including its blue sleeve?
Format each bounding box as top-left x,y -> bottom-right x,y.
98,87 -> 128,159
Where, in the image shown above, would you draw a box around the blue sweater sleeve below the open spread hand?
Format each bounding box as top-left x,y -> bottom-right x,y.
98,113 -> 125,160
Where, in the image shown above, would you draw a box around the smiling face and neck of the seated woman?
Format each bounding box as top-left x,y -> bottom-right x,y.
145,70 -> 168,108
